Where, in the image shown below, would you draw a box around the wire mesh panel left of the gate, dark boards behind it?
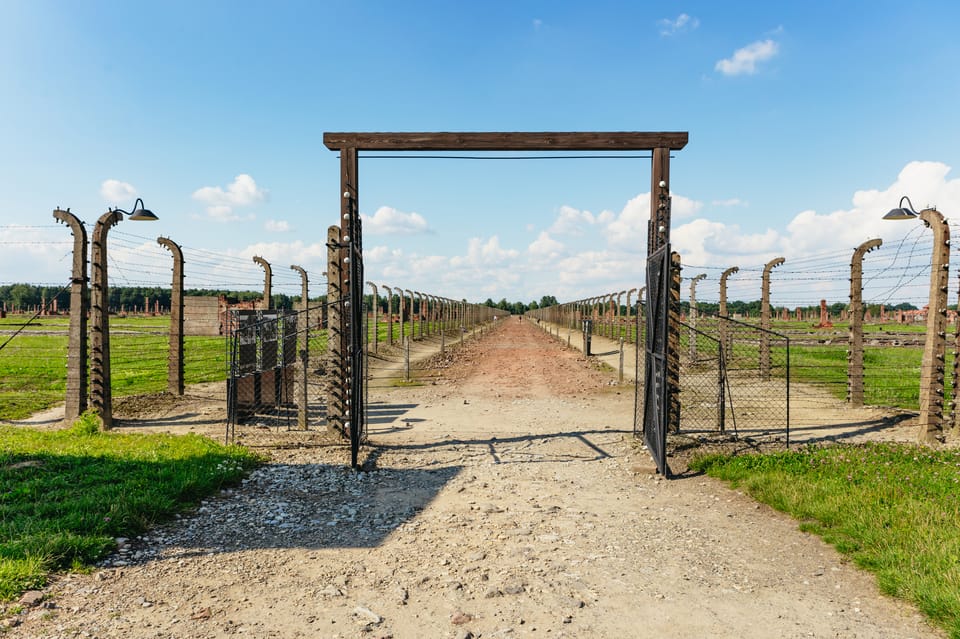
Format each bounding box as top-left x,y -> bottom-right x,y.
226,306 -> 328,441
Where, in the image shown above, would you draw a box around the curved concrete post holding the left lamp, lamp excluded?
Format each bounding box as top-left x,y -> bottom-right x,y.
90,211 -> 123,430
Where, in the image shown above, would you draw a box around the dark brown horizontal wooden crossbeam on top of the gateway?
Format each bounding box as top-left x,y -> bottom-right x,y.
323,131 -> 689,151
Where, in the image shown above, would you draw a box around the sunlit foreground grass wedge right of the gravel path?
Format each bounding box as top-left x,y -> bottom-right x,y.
692,444 -> 960,639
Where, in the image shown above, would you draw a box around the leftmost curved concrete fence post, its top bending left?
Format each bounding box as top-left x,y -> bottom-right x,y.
53,209 -> 90,421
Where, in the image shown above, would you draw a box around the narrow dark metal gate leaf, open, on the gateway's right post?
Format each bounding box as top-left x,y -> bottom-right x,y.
633,244 -> 670,477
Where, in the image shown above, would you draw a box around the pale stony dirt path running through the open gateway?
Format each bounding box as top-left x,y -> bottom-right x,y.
8,319 -> 943,639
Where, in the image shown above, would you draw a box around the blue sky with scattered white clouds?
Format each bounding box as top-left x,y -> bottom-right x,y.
0,0 -> 960,305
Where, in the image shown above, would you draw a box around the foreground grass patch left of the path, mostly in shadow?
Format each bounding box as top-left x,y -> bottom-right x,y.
0,414 -> 259,601
